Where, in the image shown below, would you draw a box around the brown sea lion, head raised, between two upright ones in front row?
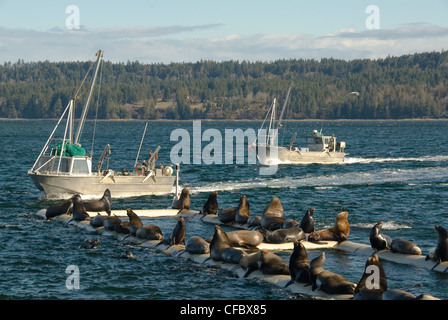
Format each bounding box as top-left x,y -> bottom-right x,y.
310,252 -> 356,294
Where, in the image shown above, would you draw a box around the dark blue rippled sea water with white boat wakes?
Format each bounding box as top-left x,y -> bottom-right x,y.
0,121 -> 448,300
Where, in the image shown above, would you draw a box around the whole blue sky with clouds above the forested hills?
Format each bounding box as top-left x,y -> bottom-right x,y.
0,0 -> 448,63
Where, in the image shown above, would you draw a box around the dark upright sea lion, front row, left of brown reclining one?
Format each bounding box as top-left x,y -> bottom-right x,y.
285,241 -> 310,288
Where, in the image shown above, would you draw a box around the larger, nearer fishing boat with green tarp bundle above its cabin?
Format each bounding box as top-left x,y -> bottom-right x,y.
28,50 -> 179,198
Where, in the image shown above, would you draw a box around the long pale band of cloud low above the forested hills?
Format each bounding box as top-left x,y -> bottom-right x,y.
0,24 -> 448,63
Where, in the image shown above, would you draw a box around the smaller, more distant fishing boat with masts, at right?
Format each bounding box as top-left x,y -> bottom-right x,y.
252,87 -> 346,165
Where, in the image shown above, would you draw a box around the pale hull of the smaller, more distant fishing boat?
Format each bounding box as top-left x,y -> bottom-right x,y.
257,146 -> 346,165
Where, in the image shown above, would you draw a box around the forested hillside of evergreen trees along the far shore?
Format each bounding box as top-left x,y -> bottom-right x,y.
0,51 -> 448,119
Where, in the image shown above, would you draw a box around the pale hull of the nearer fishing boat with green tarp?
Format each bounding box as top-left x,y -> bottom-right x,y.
29,169 -> 176,199
